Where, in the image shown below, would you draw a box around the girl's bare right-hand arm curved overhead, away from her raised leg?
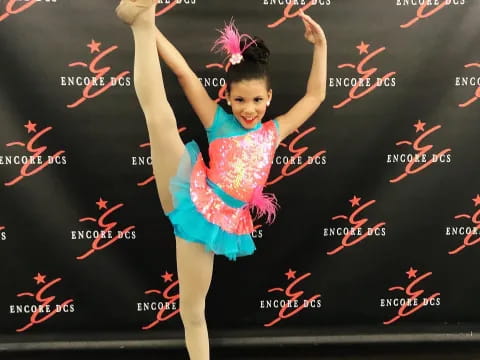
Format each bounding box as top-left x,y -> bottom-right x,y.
277,12 -> 327,140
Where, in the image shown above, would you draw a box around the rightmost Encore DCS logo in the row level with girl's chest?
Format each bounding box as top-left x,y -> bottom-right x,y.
387,120 -> 452,183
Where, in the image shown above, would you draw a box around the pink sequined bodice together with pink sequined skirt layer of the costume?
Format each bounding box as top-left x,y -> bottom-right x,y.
190,121 -> 278,235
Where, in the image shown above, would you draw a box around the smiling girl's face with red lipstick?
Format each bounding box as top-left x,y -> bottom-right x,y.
227,79 -> 272,129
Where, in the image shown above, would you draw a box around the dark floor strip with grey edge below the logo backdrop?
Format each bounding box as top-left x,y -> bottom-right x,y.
0,326 -> 480,360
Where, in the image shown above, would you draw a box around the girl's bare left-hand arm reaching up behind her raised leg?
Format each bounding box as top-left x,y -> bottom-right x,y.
156,29 -> 217,128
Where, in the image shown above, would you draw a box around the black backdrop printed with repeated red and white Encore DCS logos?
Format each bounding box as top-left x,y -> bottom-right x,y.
0,0 -> 480,344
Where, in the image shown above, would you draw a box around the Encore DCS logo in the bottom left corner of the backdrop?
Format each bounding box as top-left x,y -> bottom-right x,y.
9,273 -> 75,332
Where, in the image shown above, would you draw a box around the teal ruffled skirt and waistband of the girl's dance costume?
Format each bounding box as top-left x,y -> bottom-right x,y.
166,141 -> 255,260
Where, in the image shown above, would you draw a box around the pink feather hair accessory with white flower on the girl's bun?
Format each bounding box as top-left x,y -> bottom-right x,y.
212,18 -> 255,65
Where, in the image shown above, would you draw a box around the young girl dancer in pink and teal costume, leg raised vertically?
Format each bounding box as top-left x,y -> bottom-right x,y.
116,0 -> 327,360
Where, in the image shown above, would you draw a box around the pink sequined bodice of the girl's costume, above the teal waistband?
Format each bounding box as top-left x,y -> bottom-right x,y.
207,121 -> 278,202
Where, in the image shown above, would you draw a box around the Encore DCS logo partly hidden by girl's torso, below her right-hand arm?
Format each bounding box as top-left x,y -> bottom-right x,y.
267,126 -> 327,185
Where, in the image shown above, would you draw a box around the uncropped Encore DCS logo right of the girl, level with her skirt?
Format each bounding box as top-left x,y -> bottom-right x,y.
323,195 -> 387,255
